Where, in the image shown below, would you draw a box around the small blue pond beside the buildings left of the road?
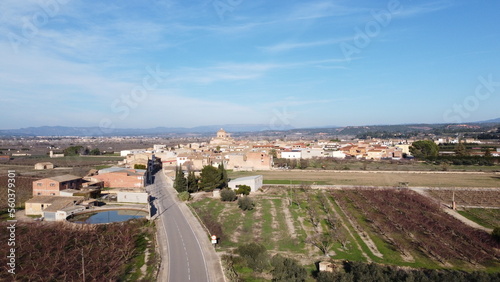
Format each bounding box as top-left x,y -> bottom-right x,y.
68,210 -> 148,224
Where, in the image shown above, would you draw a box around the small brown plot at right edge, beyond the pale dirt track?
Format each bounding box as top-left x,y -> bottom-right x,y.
427,189 -> 500,208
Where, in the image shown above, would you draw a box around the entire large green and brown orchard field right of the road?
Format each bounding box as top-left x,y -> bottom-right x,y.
189,187 -> 500,279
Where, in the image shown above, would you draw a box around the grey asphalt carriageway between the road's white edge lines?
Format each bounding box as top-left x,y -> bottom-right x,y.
148,172 -> 210,282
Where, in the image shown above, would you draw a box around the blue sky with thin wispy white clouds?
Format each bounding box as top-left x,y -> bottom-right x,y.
0,0 -> 500,129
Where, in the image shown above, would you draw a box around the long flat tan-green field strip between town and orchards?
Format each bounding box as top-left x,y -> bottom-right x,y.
228,170 -> 500,187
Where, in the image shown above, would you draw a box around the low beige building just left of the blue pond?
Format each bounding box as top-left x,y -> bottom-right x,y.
25,196 -> 84,219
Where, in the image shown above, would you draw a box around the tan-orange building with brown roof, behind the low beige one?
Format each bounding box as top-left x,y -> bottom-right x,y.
33,174 -> 83,196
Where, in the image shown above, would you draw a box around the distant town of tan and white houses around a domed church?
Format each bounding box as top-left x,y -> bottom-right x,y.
120,129 -> 411,171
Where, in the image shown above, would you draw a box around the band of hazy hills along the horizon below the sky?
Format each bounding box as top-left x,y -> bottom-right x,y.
0,118 -> 500,138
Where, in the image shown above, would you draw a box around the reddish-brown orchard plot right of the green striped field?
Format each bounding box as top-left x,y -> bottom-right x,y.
331,189 -> 500,269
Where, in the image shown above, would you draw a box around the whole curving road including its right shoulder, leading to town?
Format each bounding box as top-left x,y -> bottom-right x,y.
147,171 -> 224,282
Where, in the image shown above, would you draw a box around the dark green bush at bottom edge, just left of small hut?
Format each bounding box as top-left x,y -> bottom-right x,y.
271,254 -> 307,282
